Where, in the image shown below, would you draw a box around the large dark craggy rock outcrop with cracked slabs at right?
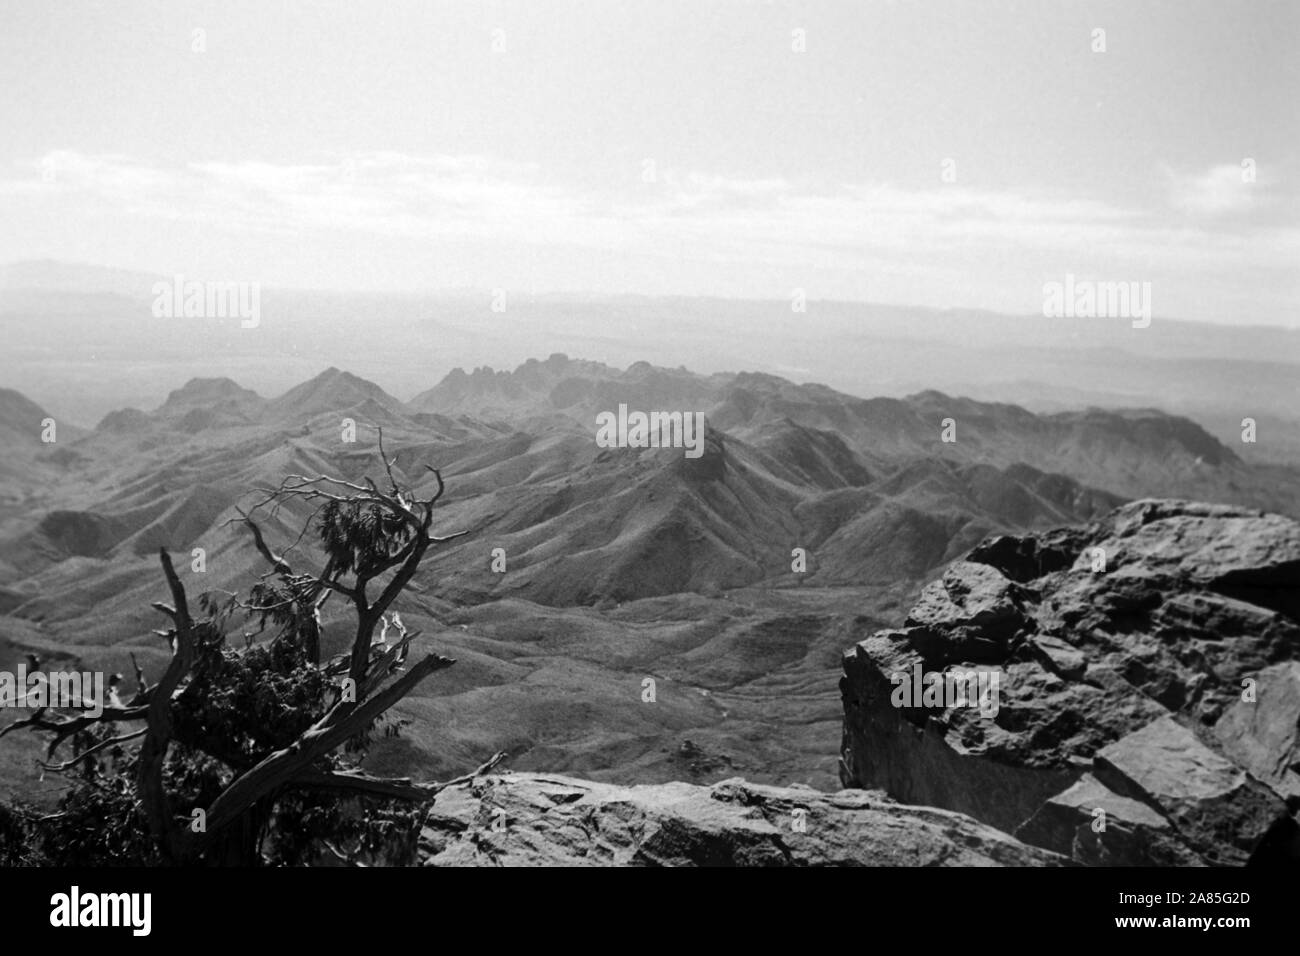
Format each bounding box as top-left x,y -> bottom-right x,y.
840,501 -> 1300,865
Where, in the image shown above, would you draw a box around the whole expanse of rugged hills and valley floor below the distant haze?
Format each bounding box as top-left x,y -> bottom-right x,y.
0,355 -> 1300,800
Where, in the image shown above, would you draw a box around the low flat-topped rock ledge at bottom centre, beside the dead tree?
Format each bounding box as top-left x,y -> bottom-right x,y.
420,774 -> 1067,866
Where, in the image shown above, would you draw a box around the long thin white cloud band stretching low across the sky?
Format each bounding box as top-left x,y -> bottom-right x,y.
0,151 -> 1300,285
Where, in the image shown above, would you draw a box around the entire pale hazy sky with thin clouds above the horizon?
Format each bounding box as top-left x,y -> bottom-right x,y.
0,0 -> 1300,325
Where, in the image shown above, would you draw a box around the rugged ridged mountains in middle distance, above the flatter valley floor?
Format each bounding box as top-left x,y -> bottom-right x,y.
0,354 -> 1300,595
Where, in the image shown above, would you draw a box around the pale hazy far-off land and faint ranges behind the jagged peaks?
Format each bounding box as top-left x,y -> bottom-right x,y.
0,261 -> 1300,464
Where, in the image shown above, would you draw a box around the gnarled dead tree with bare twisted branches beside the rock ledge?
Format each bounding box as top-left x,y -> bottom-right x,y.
0,431 -> 504,864
